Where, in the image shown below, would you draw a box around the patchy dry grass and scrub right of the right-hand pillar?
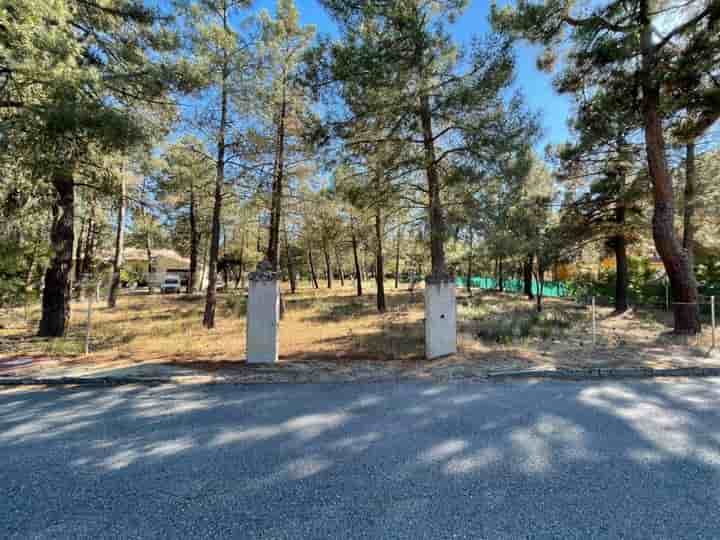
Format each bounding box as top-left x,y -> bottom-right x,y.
459,293 -> 718,368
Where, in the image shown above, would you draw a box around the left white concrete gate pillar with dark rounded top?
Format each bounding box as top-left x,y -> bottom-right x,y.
247,261 -> 280,364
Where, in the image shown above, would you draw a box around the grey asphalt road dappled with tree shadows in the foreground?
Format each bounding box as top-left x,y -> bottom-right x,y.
0,379 -> 720,540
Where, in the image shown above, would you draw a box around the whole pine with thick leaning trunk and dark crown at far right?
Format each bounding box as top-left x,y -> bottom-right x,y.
492,0 -> 720,334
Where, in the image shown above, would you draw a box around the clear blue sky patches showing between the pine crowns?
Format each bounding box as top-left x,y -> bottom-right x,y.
254,0 -> 571,150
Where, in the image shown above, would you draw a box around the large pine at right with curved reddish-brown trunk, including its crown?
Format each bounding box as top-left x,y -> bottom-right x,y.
493,0 -> 720,334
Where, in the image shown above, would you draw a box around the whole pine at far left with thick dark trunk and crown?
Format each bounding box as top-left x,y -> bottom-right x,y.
0,0 -> 182,337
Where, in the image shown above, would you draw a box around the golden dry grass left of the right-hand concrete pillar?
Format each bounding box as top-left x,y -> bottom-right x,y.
0,284 -> 423,368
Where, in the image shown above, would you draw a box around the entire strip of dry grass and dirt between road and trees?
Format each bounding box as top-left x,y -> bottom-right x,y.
0,283 -> 720,381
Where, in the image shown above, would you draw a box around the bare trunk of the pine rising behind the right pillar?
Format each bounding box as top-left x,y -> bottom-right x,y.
418,94 -> 447,278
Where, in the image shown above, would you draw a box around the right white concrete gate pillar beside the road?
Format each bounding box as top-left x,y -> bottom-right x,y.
425,276 -> 457,360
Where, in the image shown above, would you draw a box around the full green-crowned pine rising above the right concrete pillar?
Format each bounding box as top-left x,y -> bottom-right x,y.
313,0 -> 537,271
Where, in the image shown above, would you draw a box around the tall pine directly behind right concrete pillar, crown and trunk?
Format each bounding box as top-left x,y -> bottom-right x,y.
316,0 -> 535,279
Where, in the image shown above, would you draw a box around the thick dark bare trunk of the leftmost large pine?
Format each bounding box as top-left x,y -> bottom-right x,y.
38,172 -> 75,337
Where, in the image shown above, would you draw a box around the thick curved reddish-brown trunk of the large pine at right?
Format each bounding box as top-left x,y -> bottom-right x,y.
640,0 -> 700,334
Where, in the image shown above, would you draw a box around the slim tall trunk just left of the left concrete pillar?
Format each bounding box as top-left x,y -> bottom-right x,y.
203,39 -> 230,329
